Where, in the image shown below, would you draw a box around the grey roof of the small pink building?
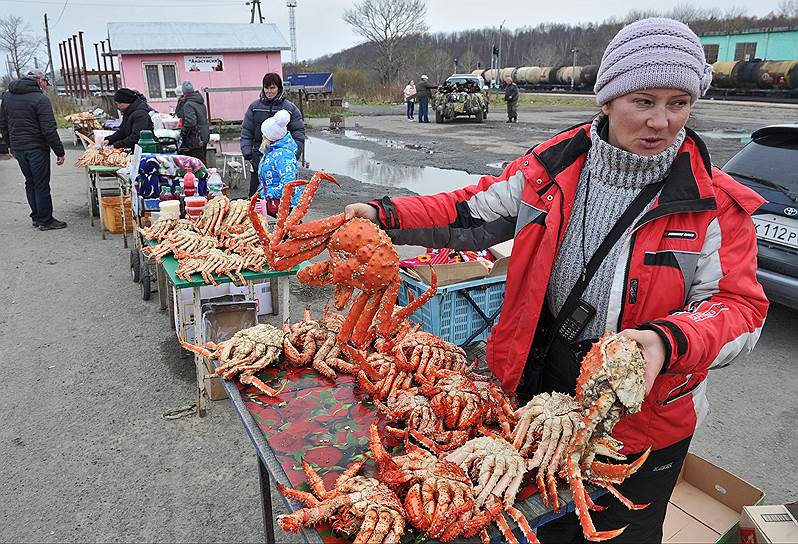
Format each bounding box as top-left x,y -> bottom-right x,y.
108,21 -> 291,53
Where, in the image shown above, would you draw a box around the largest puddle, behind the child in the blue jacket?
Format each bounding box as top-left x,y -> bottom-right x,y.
305,136 -> 481,195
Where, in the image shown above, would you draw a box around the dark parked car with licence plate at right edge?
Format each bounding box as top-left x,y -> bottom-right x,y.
723,123 -> 798,309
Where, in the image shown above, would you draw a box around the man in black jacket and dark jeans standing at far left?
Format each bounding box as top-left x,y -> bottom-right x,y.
0,70 -> 66,230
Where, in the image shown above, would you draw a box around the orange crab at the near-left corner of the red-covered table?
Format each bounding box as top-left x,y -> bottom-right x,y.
277,460 -> 405,544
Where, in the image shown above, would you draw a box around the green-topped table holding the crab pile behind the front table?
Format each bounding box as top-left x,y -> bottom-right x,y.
154,241 -> 301,417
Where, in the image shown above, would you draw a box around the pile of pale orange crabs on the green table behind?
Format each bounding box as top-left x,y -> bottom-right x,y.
138,196 -> 266,285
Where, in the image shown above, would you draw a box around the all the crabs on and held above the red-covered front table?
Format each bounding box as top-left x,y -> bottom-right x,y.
178,175 -> 647,543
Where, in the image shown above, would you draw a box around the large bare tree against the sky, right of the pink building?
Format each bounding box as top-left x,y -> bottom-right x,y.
344,0 -> 427,85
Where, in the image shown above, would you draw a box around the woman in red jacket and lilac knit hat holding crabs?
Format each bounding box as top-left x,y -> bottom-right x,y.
346,18 -> 768,543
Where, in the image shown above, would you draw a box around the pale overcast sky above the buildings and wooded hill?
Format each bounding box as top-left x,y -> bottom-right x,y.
0,0 -> 779,72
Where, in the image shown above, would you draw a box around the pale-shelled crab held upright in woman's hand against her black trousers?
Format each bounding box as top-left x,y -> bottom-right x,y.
565,333 -> 649,541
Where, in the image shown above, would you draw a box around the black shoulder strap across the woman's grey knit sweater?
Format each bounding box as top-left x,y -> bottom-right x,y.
548,181 -> 664,346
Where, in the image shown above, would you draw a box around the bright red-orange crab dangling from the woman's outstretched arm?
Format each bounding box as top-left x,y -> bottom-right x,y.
249,172 -> 436,346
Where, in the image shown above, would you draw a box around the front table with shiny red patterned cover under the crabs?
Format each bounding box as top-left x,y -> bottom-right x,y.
223,362 -> 602,543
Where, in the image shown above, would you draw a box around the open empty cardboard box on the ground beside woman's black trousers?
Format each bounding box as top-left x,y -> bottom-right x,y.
662,453 -> 765,544
